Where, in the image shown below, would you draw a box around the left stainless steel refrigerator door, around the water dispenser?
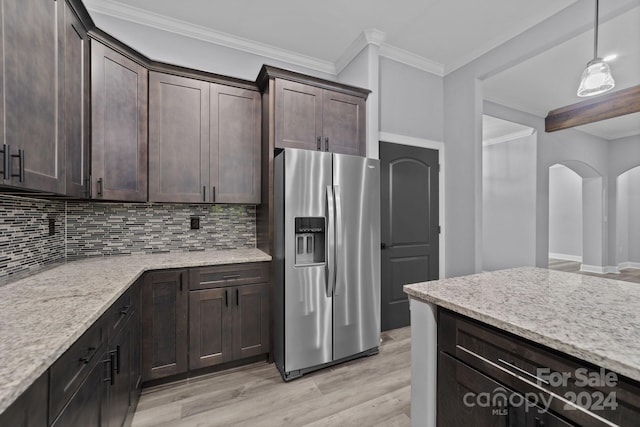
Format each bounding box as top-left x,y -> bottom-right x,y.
283,149 -> 332,371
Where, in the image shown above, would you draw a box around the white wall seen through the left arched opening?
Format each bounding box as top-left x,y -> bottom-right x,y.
549,165 -> 582,261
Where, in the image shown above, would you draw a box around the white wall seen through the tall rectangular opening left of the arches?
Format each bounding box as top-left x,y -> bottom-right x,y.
482,134 -> 536,271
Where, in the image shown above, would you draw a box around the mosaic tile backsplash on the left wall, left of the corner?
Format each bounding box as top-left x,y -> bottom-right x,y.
0,195 -> 65,283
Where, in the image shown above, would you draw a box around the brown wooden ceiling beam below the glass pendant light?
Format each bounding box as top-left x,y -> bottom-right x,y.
544,85 -> 640,132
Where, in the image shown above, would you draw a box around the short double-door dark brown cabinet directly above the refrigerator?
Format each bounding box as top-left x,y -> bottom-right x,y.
258,66 -> 369,156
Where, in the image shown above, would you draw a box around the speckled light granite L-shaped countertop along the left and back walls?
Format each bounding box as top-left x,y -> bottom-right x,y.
0,249 -> 271,413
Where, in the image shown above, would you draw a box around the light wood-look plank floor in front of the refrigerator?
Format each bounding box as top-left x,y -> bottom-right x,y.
133,327 -> 411,427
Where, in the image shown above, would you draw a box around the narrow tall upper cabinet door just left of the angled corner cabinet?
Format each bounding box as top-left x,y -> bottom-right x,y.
60,2 -> 90,197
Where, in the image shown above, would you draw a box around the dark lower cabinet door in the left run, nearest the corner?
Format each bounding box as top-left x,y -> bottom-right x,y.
103,317 -> 132,427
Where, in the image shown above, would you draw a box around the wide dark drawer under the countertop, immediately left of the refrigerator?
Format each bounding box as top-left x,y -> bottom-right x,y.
189,262 -> 269,290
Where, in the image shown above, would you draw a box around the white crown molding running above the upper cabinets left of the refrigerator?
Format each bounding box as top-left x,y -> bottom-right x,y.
84,0 -> 337,75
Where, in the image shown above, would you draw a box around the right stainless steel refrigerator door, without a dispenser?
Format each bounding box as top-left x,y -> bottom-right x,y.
333,154 -> 380,359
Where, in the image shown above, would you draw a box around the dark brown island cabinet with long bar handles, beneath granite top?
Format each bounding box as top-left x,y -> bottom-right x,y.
438,309 -> 640,427
